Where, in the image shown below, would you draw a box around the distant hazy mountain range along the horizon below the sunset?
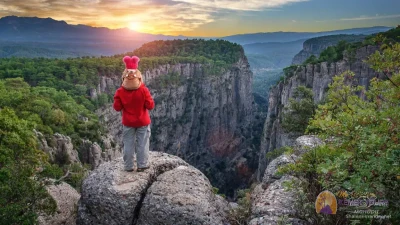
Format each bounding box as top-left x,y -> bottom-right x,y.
0,16 -> 390,57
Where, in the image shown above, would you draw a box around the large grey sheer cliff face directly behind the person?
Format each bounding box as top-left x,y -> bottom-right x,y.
92,55 -> 257,196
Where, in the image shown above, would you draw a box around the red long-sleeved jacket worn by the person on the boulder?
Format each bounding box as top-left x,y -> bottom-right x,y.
113,83 -> 154,128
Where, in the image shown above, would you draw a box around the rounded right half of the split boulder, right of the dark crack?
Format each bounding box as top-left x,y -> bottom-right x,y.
138,166 -> 228,225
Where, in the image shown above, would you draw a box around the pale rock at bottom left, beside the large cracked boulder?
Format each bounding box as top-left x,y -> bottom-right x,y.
38,182 -> 80,225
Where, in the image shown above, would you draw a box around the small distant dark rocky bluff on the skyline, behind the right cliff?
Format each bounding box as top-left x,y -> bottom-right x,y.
292,34 -> 366,65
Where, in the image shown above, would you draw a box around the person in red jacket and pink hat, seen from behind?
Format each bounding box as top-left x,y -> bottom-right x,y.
113,56 -> 154,172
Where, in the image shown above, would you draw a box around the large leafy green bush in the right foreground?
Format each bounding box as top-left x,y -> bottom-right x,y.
281,43 -> 400,224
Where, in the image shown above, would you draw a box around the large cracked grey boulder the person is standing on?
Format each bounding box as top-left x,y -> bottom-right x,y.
77,152 -> 228,225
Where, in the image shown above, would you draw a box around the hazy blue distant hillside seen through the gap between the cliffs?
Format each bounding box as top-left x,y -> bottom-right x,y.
238,27 -> 389,96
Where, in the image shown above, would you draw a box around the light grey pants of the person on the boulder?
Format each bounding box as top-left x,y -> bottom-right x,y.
123,125 -> 150,170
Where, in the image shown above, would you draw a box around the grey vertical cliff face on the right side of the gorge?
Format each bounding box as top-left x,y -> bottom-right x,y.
257,46 -> 379,180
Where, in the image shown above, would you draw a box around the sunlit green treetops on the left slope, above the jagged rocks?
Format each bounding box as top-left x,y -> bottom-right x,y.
0,78 -> 101,150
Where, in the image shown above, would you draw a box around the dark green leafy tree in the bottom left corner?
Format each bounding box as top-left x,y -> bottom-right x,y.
0,107 -> 56,224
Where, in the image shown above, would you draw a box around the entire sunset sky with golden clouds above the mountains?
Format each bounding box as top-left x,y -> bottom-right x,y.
0,0 -> 400,37
